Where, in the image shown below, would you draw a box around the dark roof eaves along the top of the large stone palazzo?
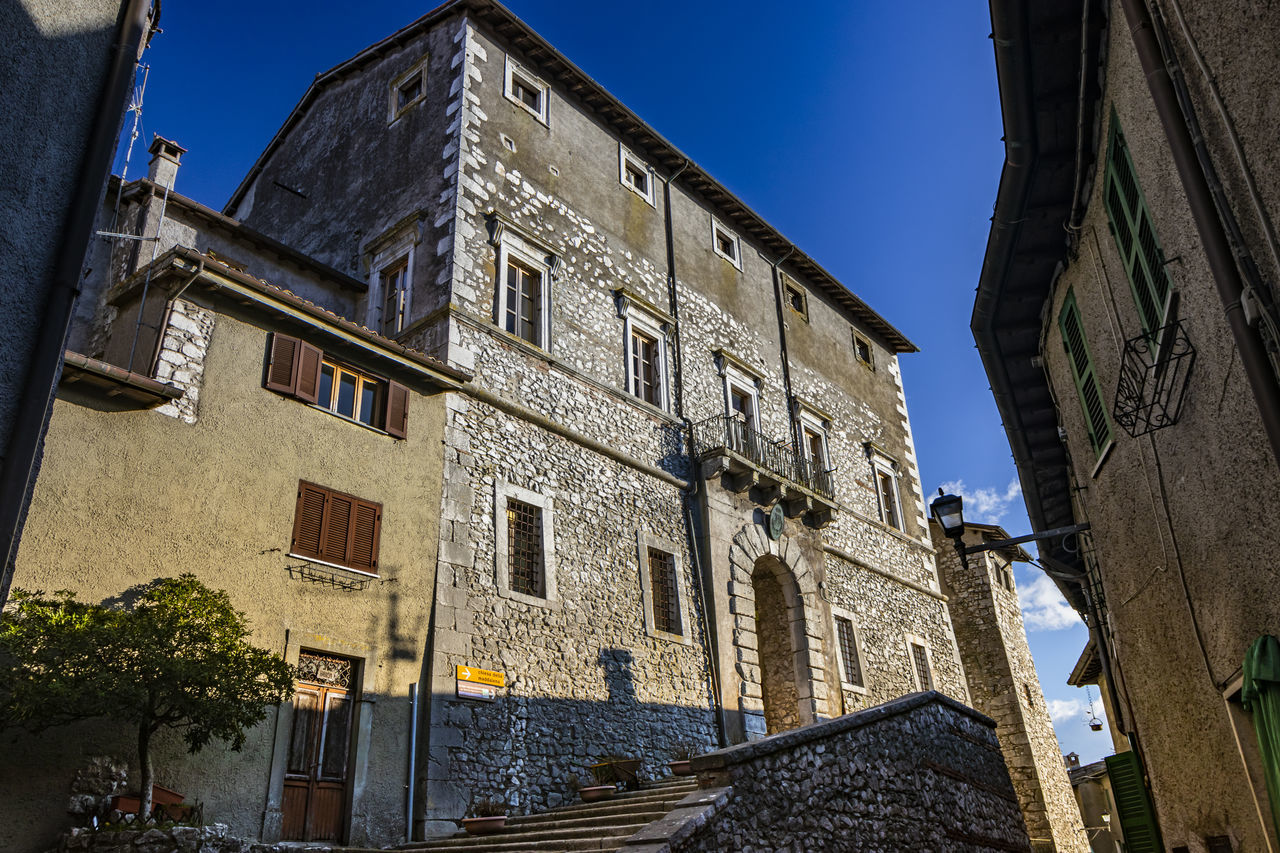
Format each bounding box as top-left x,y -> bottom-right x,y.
223,0 -> 919,353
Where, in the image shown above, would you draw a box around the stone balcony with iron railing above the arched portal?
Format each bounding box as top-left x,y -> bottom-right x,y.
692,415 -> 836,528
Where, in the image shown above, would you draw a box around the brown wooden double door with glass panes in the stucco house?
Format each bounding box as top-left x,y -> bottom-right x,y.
283,652 -> 355,841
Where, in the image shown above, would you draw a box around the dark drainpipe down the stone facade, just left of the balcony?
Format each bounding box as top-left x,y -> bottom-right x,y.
662,160 -> 728,748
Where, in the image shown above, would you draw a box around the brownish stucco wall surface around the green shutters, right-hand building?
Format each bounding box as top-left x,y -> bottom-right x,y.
1043,8 -> 1280,849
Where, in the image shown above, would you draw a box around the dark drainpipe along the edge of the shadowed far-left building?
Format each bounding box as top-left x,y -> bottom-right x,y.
0,0 -> 151,607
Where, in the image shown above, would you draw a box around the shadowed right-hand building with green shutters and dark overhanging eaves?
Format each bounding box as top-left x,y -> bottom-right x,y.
973,0 -> 1280,853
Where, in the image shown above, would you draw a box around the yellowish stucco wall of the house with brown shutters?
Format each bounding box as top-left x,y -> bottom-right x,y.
0,307 -> 443,849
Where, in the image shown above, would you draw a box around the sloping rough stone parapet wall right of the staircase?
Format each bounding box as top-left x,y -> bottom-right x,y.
677,693 -> 1030,853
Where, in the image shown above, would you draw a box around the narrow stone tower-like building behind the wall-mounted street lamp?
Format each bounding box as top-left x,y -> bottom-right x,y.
929,520 -> 1089,852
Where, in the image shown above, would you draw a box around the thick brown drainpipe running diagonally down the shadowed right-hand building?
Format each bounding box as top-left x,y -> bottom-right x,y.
1120,0 -> 1280,464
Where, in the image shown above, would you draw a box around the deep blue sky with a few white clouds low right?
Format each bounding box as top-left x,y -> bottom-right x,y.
116,0 -> 1110,761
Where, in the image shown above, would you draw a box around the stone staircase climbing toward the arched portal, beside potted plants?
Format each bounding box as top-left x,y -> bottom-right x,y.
384,777 -> 698,853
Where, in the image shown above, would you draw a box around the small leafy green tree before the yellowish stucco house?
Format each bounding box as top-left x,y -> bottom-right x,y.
0,574 -> 294,815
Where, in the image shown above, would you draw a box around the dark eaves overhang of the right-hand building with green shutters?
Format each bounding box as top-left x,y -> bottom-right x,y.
970,0 -> 1106,612
